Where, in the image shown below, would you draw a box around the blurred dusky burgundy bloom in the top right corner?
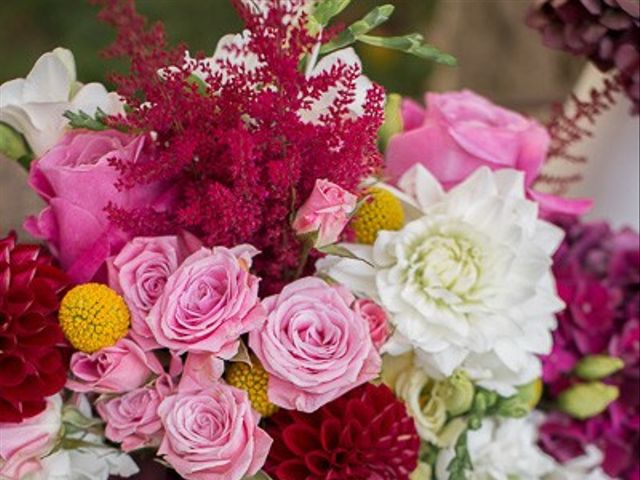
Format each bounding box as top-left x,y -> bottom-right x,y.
527,0 -> 640,112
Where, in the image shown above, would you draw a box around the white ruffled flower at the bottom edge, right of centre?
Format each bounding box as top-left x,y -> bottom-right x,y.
435,418 -> 555,480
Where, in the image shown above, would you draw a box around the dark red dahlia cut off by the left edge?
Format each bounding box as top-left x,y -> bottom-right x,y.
0,233 -> 69,422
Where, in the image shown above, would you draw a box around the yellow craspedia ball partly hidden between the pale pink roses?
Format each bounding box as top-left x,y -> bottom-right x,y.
225,356 -> 278,417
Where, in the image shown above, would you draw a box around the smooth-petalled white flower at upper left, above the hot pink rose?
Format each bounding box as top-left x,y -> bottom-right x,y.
0,48 -> 122,156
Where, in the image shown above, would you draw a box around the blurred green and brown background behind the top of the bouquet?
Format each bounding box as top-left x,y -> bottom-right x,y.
0,0 -> 583,234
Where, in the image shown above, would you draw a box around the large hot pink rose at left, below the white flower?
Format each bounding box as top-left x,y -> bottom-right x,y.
25,130 -> 168,283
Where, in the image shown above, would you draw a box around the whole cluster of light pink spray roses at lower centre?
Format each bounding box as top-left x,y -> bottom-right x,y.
60,235 -> 386,480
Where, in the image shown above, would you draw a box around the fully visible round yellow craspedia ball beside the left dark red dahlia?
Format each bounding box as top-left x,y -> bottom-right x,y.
58,283 -> 130,353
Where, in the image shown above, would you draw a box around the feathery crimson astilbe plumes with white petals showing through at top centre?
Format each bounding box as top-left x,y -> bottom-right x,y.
92,0 -> 384,291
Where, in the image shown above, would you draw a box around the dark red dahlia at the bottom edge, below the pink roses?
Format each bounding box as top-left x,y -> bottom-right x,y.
265,384 -> 420,480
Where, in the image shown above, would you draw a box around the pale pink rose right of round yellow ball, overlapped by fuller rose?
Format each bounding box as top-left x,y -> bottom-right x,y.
107,236 -> 182,349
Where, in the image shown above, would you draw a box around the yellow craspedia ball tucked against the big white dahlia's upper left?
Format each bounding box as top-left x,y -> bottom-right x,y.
351,187 -> 404,245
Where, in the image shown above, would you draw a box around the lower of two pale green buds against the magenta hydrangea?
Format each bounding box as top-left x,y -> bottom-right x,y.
558,382 -> 620,420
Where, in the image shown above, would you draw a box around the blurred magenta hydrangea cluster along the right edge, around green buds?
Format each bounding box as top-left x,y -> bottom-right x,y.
541,218 -> 640,480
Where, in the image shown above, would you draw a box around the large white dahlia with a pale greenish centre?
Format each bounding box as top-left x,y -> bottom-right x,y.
318,167 -> 563,396
